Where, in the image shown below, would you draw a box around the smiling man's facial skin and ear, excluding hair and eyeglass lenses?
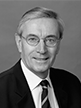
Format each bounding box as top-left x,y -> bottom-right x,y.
16,18 -> 59,78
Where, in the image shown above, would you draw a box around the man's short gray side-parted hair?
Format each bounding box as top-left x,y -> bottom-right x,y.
17,7 -> 64,39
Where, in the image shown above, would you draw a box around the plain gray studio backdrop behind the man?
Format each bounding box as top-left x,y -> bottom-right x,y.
0,0 -> 81,80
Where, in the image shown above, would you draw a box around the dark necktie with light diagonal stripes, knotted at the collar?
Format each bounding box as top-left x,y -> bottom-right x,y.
40,80 -> 50,108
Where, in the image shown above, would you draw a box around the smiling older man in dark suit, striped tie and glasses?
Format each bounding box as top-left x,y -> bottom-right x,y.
0,7 -> 81,108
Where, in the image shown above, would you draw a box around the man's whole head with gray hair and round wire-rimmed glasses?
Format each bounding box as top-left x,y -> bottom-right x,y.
15,7 -> 63,78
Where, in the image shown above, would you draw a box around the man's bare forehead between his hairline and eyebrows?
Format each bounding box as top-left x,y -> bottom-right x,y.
22,18 -> 58,35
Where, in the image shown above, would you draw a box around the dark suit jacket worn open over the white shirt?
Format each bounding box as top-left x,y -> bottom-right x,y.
0,61 -> 81,108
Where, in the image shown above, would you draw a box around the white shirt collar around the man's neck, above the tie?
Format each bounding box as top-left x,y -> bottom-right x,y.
21,60 -> 50,91
